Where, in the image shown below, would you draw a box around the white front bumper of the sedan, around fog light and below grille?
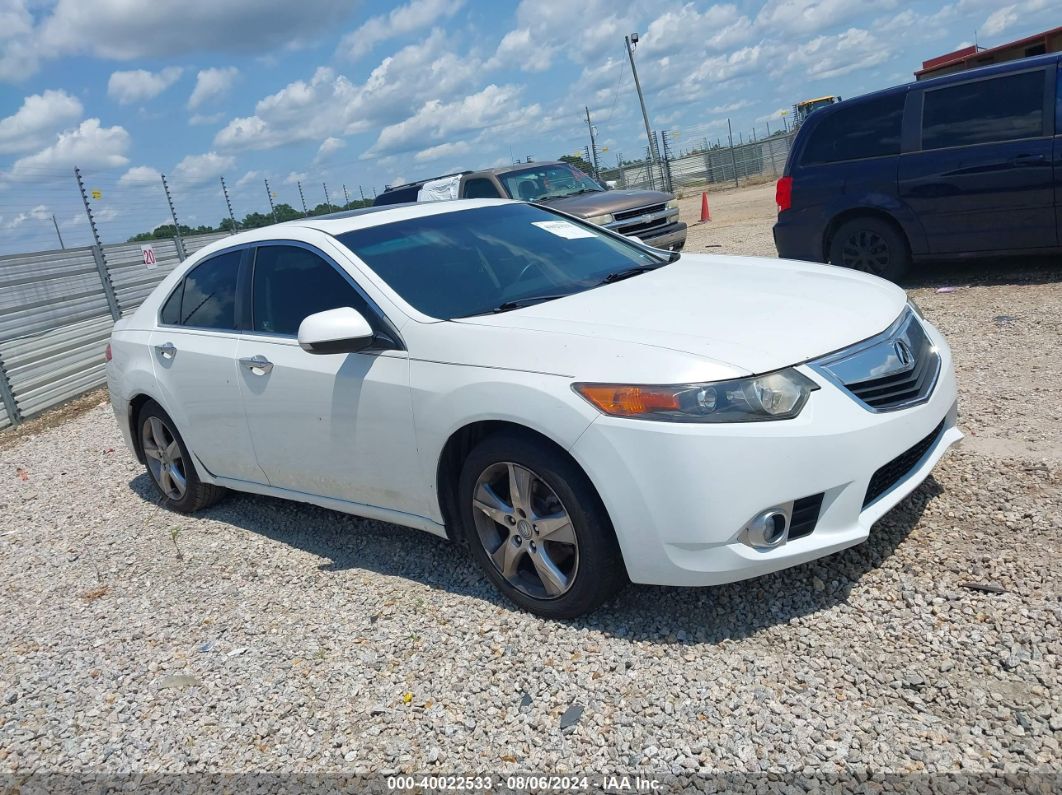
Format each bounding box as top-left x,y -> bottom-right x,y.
571,318 -> 962,586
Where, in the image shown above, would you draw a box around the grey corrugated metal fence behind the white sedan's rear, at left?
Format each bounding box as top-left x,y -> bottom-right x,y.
0,232 -> 225,428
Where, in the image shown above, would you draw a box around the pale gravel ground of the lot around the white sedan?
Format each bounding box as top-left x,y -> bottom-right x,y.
0,186 -> 1062,776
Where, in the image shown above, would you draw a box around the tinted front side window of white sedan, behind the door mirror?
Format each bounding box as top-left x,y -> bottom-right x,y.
252,245 -> 373,336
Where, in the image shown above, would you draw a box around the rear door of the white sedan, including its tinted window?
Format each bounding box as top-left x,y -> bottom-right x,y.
150,248 -> 266,483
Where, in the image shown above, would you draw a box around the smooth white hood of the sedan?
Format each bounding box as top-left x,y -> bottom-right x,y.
449,255 -> 907,380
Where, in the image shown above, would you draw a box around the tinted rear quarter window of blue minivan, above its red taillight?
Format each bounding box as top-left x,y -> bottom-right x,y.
801,91 -> 905,163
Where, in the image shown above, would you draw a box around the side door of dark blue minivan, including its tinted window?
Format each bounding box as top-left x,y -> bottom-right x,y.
900,67 -> 1058,255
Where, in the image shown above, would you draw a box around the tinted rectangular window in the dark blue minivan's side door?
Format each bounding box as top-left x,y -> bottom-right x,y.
922,69 -> 1044,150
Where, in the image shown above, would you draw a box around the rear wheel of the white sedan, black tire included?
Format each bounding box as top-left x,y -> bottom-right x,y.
136,400 -> 225,514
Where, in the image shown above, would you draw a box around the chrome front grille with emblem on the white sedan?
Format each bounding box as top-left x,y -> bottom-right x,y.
811,310 -> 941,412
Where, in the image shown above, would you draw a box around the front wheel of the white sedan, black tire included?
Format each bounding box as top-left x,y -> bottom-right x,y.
458,433 -> 627,618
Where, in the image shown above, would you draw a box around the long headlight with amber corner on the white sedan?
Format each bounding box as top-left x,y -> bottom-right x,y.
571,369 -> 819,422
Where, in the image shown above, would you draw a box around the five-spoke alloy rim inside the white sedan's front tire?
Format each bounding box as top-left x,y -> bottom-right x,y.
473,462 -> 579,599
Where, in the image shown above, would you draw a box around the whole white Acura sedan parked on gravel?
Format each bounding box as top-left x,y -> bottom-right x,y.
107,200 -> 961,617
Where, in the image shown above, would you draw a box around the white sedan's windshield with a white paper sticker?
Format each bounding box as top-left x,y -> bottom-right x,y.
338,204 -> 668,319
